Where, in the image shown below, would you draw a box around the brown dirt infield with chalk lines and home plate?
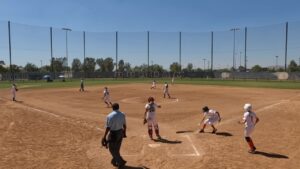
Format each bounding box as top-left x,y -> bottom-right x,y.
0,84 -> 300,169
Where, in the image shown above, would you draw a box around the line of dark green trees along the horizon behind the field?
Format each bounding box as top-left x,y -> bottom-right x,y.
0,57 -> 300,73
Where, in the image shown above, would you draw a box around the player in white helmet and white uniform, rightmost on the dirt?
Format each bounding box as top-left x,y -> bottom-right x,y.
239,103 -> 259,153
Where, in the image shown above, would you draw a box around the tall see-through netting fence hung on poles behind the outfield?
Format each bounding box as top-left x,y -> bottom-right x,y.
0,21 -> 300,78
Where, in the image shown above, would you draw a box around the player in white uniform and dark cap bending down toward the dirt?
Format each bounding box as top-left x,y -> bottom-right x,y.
199,106 -> 221,134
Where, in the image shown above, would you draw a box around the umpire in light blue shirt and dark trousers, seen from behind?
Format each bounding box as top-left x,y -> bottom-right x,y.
102,103 -> 126,168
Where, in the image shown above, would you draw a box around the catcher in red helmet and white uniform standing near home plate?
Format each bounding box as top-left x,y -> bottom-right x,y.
144,97 -> 161,140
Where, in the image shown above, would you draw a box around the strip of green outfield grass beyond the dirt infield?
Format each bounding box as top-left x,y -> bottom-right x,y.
0,78 -> 300,89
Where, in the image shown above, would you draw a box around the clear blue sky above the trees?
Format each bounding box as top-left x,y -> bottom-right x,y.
0,0 -> 300,68
